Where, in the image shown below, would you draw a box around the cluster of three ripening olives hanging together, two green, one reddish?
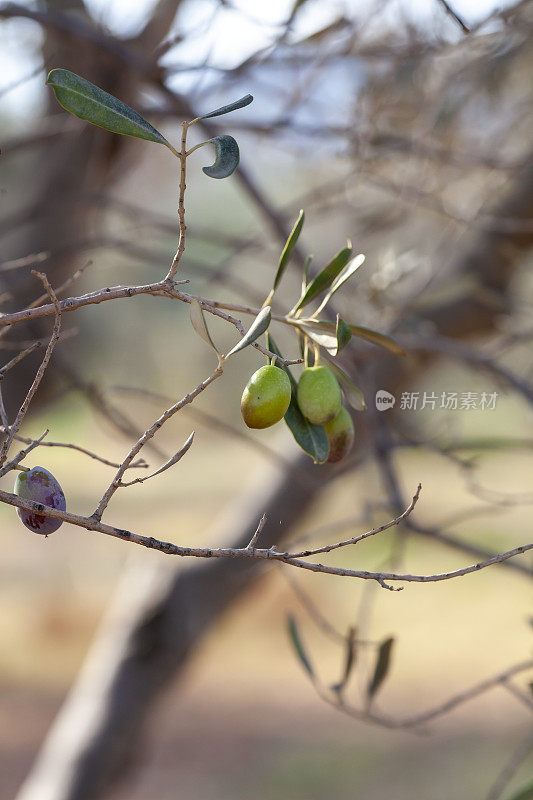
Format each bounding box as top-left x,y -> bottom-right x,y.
241,365 -> 354,462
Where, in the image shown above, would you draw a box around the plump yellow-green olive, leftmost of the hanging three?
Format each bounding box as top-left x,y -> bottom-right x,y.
241,365 -> 291,428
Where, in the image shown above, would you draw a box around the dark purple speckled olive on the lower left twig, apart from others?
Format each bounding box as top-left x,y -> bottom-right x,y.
15,467 -> 67,536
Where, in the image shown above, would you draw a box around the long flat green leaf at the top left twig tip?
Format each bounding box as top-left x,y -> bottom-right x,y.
46,69 -> 173,149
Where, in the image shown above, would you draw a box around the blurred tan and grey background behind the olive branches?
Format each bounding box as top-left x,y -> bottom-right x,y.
0,0 -> 533,800
